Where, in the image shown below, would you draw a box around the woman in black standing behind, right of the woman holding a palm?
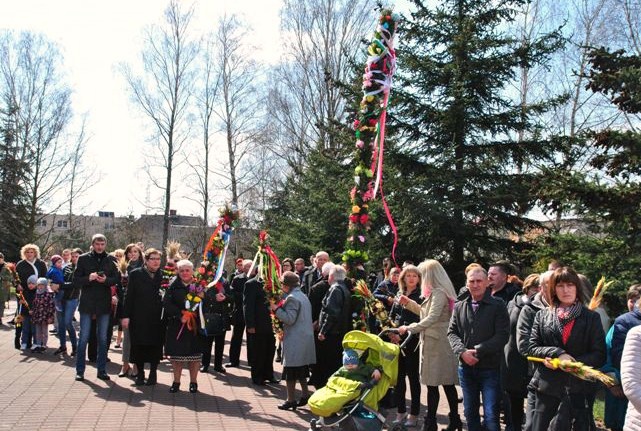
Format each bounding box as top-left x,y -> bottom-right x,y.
200,280 -> 234,374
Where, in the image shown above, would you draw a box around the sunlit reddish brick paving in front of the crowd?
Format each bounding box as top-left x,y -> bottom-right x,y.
0,308 -> 462,431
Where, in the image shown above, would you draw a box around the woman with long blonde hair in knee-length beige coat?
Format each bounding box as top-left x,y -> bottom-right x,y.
399,259 -> 462,431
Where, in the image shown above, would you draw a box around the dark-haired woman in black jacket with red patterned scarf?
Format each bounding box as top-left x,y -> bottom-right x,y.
528,267 -> 606,431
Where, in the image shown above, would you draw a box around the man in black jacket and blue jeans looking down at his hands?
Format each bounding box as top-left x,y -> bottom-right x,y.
73,234 -> 118,381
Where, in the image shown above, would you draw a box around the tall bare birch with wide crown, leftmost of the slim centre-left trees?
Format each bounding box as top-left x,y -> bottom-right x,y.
122,0 -> 198,247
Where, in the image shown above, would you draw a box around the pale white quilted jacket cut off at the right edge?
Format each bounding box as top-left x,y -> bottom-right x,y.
621,326 -> 641,431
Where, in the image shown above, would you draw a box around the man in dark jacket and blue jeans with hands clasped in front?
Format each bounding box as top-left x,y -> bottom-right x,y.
447,267 -> 510,431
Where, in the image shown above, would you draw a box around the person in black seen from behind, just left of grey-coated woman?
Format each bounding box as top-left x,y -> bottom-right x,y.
243,277 -> 278,386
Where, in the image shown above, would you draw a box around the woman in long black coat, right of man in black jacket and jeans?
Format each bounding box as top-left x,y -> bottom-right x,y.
122,248 -> 164,386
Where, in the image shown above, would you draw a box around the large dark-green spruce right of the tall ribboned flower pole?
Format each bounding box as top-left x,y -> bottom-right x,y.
388,0 -> 561,281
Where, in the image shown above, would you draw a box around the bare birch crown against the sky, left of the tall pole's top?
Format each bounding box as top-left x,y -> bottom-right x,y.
269,0 -> 375,171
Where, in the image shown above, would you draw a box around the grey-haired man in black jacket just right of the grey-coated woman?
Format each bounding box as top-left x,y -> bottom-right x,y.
313,265 -> 352,388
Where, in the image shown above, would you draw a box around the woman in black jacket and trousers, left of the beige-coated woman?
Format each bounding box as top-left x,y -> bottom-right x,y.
390,265 -> 422,427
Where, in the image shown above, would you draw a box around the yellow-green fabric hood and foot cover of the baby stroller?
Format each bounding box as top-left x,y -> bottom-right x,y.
308,331 -> 399,417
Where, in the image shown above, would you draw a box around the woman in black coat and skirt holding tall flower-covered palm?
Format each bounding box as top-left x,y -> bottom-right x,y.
163,260 -> 204,393
